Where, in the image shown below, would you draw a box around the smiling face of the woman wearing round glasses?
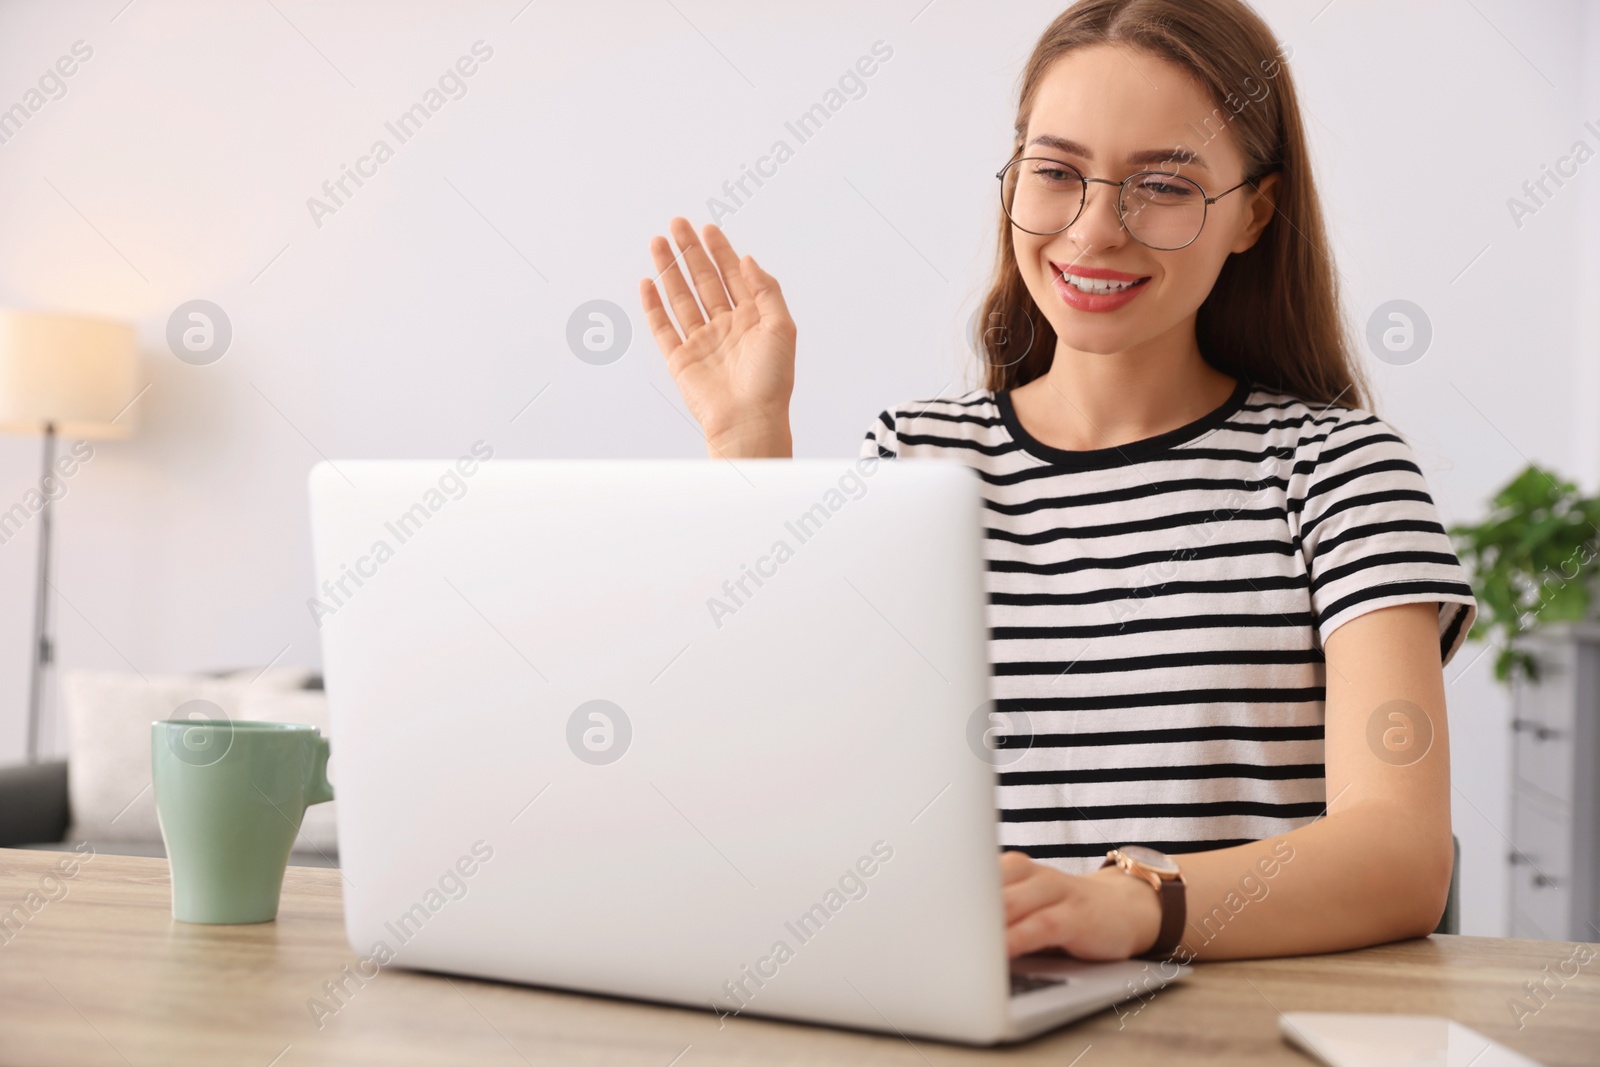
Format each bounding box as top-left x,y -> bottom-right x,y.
1011,45 -> 1277,354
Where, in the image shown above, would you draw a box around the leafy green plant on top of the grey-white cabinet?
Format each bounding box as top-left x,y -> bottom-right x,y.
1450,466 -> 1600,683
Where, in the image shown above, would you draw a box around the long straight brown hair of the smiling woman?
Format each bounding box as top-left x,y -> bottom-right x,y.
976,0 -> 1371,411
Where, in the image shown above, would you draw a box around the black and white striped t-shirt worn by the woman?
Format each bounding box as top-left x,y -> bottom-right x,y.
862,379 -> 1477,873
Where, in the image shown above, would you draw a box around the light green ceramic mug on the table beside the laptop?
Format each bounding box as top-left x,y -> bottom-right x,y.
150,718 -> 333,923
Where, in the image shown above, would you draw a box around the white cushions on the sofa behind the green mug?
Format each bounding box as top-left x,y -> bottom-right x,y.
61,667 -> 334,856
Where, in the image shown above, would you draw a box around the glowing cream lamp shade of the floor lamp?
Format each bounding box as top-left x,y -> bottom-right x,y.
0,309 -> 139,440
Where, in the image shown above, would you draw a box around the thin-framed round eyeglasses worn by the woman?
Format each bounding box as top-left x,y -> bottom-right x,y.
995,155 -> 1254,251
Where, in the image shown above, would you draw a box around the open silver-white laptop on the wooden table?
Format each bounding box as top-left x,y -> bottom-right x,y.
307,454 -> 1178,1045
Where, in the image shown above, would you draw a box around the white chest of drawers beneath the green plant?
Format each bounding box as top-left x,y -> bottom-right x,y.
1507,622 -> 1600,942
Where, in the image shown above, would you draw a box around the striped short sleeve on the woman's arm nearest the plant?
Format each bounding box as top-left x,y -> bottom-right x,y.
1291,410 -> 1478,664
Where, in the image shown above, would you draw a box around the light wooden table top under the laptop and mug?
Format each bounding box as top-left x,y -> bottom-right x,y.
0,849 -> 1600,1067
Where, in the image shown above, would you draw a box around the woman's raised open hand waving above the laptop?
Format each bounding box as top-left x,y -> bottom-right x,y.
638,218 -> 795,459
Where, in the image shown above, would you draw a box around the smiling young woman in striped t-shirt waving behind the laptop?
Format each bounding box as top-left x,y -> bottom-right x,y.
640,0 -> 1477,960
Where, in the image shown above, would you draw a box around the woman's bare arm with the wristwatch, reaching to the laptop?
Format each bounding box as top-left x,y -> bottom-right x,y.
1003,603 -> 1453,960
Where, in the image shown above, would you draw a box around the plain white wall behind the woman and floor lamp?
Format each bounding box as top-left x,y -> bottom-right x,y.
0,0 -> 1600,933
